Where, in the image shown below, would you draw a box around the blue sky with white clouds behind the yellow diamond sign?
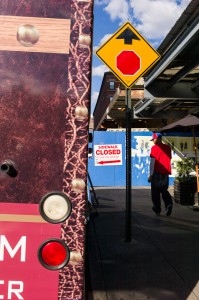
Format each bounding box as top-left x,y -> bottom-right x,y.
91,0 -> 191,113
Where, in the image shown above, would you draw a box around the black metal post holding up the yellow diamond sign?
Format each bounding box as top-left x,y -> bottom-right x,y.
125,88 -> 131,242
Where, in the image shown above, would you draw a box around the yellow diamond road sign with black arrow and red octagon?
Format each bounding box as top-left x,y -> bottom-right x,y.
96,22 -> 160,88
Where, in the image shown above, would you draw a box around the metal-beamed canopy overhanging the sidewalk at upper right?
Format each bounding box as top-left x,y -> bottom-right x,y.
134,0 -> 199,119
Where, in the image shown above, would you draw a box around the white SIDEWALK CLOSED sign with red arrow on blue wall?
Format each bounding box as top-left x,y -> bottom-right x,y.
94,144 -> 122,166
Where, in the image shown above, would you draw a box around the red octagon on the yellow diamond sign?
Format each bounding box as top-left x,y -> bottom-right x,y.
116,50 -> 141,75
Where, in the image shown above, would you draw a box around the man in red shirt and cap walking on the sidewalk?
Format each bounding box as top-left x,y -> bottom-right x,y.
148,132 -> 173,216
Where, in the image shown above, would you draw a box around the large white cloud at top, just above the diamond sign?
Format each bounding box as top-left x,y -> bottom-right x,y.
100,0 -> 191,39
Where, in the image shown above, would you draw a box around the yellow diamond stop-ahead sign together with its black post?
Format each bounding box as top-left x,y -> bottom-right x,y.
96,22 -> 160,242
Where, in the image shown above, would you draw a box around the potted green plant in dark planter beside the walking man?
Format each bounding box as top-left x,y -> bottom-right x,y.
174,157 -> 197,205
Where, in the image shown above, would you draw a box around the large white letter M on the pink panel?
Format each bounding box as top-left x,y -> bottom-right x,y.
0,235 -> 26,262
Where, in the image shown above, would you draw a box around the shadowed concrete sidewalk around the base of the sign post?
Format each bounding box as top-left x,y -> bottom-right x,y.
86,187 -> 199,300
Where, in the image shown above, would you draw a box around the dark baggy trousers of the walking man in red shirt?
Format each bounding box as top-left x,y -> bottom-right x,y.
151,172 -> 173,213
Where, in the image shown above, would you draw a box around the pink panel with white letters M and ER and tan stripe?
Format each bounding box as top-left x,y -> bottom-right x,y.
0,203 -> 60,300
